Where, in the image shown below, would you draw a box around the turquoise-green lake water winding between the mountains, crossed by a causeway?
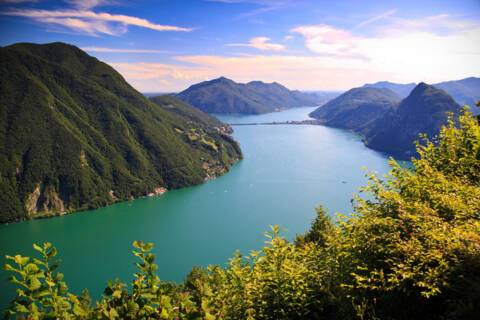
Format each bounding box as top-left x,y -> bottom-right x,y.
0,108 -> 388,310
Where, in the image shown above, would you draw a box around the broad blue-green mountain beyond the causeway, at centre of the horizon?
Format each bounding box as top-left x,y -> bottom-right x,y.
177,77 -> 319,114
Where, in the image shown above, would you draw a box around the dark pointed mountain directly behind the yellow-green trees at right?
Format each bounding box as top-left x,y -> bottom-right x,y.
364,82 -> 461,159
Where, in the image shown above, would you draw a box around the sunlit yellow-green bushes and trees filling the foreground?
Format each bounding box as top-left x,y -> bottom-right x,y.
5,110 -> 480,319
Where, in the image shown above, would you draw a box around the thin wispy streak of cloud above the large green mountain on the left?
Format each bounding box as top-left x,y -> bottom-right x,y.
1,8 -> 193,35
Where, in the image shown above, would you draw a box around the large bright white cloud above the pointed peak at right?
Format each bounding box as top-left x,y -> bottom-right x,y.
292,15 -> 480,82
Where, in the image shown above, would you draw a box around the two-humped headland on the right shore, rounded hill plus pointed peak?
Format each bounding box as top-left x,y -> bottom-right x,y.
310,82 -> 461,159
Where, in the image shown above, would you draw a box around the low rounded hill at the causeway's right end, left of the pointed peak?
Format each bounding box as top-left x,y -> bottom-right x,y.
310,87 -> 401,132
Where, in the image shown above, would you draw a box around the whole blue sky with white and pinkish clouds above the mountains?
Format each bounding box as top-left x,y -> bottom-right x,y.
0,0 -> 480,92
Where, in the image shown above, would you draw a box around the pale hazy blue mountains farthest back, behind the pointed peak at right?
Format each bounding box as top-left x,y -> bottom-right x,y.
364,77 -> 480,114
